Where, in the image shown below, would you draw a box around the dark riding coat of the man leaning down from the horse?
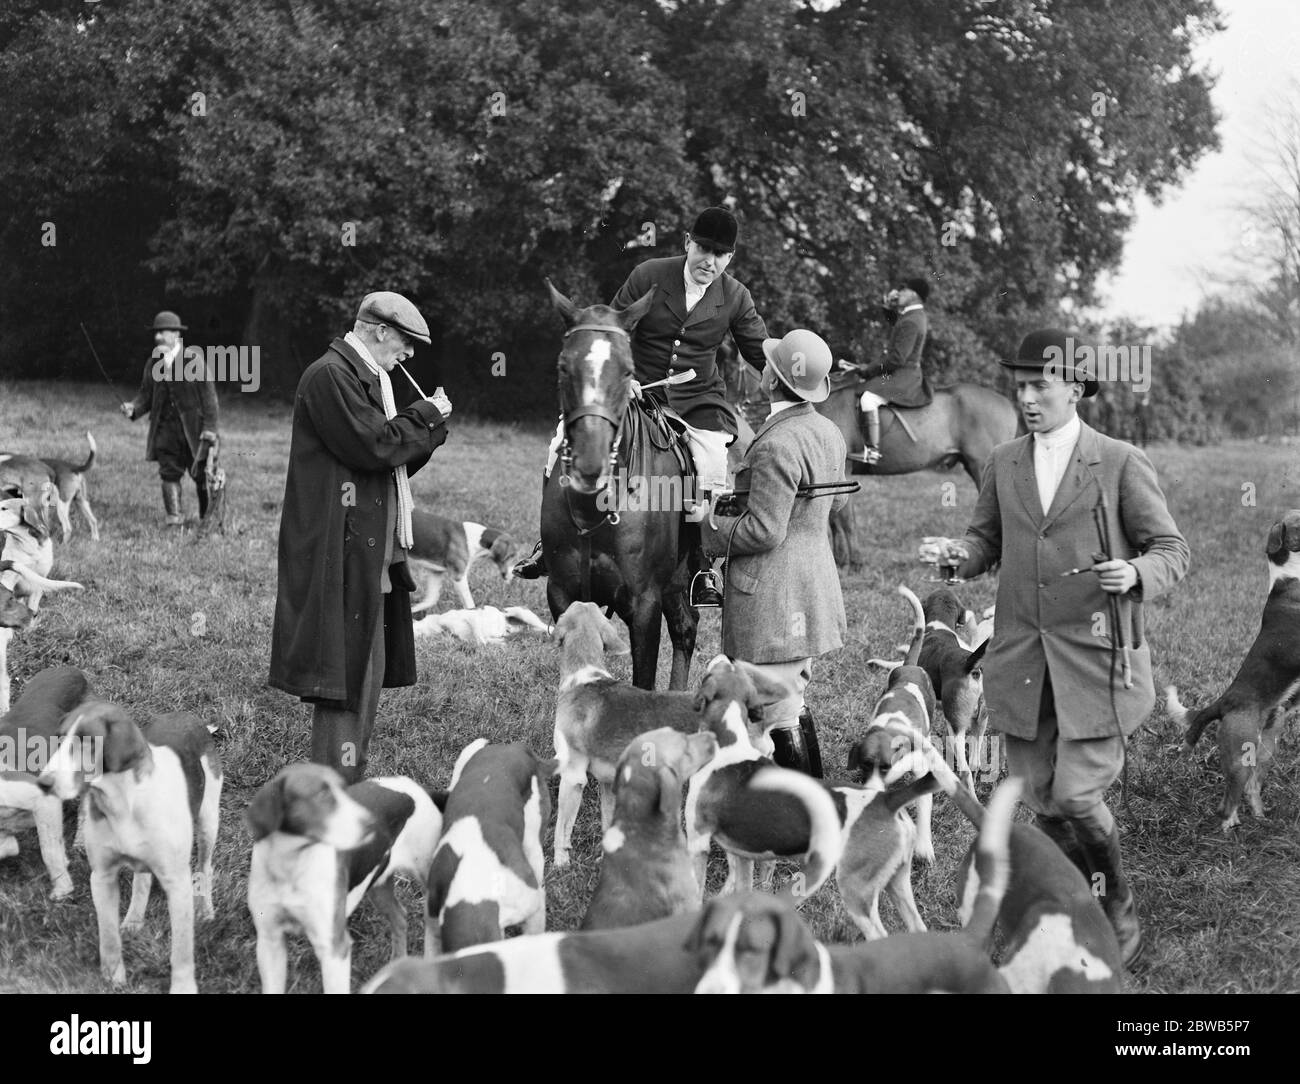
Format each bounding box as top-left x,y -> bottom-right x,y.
610,256 -> 767,433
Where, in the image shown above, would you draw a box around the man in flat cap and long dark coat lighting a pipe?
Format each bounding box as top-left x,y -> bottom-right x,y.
270,292 -> 451,782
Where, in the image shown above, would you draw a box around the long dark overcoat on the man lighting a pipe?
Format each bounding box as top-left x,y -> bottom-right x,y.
270,339 -> 447,708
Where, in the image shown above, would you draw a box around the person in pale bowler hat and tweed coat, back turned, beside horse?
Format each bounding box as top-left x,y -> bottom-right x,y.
702,330 -> 849,776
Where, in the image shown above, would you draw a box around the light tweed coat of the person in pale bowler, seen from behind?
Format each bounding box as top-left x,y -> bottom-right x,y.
701,403 -> 848,663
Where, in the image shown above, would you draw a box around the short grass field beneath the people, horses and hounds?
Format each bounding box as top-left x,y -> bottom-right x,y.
0,382 -> 1300,993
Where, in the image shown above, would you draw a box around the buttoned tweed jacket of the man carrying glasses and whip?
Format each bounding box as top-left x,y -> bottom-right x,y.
958,424 -> 1191,740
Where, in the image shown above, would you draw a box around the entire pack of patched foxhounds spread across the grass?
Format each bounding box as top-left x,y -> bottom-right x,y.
0,434 -> 1300,993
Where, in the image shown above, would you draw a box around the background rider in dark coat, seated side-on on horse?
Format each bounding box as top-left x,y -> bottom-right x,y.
841,277 -> 935,464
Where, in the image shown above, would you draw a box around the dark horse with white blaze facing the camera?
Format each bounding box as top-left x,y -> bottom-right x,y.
541,281 -> 698,689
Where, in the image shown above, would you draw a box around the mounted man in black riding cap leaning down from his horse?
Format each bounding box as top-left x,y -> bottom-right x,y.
515,207 -> 767,606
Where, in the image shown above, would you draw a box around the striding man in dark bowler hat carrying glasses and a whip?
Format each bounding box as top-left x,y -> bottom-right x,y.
922,328 -> 1191,966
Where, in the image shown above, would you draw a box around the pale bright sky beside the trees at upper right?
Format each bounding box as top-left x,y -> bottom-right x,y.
1099,0 -> 1300,328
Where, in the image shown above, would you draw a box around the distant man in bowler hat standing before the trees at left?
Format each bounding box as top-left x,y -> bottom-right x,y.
120,312 -> 217,526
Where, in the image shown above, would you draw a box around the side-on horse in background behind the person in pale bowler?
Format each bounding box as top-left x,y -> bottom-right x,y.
722,343 -> 1023,567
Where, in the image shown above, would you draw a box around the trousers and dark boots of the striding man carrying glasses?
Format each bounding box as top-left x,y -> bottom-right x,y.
1006,677 -> 1141,964
